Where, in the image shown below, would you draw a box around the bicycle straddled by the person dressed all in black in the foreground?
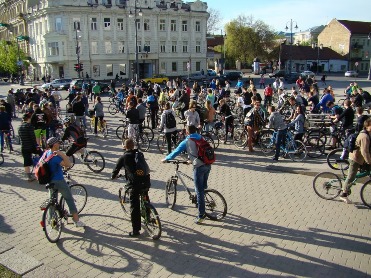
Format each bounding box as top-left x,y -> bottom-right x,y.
119,187 -> 162,240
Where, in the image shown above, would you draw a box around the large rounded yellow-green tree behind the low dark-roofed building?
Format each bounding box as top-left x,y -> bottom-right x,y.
225,16 -> 277,64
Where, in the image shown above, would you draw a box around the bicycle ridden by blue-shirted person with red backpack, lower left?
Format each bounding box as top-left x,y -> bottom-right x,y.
40,173 -> 88,243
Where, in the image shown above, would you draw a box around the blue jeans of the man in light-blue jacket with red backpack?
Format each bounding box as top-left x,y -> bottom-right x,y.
193,165 -> 211,217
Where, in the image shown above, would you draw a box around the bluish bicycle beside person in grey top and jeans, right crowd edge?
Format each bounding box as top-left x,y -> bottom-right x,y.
260,130 -> 308,161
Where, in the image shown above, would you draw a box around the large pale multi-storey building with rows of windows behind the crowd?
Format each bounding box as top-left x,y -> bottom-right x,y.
0,0 -> 209,80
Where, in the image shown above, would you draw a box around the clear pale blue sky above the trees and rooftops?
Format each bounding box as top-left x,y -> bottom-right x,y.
205,0 -> 371,33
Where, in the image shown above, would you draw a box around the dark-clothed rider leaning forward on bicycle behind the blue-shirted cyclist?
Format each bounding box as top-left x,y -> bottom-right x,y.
61,118 -> 87,157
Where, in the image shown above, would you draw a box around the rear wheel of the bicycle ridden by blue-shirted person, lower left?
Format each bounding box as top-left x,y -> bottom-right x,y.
42,204 -> 63,243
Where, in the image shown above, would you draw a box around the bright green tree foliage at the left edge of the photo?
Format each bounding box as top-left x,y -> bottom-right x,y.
0,40 -> 28,74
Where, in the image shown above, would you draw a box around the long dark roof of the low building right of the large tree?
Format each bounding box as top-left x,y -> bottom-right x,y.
281,45 -> 346,60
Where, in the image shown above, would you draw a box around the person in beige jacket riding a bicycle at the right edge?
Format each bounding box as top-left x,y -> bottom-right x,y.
340,118 -> 371,204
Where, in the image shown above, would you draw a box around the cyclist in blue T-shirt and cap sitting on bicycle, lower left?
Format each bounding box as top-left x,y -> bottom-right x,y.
46,137 -> 85,227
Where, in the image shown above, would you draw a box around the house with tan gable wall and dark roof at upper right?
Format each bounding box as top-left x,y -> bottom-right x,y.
318,18 -> 371,72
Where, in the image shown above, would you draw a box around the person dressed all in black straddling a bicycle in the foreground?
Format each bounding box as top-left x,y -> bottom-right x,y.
111,138 -> 150,237
